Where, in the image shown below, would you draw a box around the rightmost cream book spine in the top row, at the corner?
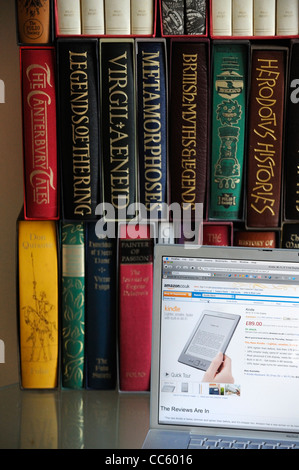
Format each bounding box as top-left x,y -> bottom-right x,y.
276,0 -> 299,36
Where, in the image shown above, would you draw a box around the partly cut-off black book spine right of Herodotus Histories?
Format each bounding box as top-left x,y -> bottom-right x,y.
284,41 -> 299,220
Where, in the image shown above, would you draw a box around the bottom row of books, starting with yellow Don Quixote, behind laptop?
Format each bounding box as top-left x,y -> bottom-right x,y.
17,216 -> 299,392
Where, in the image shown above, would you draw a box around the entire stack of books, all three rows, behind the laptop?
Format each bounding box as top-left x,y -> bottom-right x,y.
15,0 -> 299,392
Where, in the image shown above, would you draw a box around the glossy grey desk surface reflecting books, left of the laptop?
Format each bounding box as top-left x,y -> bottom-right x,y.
0,385 -> 149,449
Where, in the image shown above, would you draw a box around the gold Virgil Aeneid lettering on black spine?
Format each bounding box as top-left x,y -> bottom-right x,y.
108,52 -> 130,209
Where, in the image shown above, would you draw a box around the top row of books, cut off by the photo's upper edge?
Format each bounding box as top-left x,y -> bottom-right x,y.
16,0 -> 299,44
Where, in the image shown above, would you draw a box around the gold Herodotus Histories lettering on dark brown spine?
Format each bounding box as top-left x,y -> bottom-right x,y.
250,59 -> 281,216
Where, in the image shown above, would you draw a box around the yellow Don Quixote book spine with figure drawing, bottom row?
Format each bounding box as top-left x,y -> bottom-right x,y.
18,220 -> 58,389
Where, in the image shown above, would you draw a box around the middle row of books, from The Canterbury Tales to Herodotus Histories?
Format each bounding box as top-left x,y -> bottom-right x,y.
21,38 -> 299,230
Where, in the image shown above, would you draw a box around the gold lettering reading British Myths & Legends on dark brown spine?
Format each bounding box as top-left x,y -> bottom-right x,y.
181,54 -> 198,210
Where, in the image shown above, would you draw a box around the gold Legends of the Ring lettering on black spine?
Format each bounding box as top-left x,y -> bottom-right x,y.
69,51 -> 92,216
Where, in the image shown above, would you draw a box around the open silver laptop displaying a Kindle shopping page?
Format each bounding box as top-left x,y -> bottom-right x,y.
143,244 -> 299,449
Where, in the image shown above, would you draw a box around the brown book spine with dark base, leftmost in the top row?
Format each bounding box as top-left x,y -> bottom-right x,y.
17,0 -> 51,44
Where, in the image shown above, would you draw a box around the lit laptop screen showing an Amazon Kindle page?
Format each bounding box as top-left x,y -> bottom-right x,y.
158,256 -> 299,432
